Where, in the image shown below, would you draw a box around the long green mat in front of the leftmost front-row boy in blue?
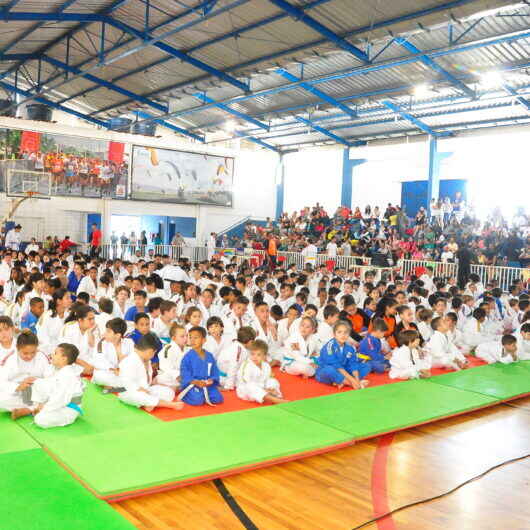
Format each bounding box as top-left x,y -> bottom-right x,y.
40,407 -> 351,496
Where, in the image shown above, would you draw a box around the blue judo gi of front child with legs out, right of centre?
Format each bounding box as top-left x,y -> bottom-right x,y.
315,339 -> 370,385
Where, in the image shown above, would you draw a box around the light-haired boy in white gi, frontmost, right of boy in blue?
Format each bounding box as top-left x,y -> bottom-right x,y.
236,339 -> 287,403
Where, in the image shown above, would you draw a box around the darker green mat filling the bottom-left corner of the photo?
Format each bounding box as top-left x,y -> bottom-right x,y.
0,449 -> 134,530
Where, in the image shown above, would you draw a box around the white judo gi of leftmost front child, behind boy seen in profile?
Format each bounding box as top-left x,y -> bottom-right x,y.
0,352 -> 53,411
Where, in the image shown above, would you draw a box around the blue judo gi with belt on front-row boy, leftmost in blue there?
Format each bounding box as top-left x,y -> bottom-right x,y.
178,350 -> 223,405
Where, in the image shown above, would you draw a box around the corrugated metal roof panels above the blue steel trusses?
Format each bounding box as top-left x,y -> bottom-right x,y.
0,0 -> 530,145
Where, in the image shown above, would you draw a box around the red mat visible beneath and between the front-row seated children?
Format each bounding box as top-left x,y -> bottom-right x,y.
149,356 -> 486,421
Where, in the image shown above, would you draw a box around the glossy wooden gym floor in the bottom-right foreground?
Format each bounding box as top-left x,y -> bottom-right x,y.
113,398 -> 530,530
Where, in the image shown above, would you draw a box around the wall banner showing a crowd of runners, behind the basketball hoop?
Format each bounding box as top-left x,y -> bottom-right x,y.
0,129 -> 129,199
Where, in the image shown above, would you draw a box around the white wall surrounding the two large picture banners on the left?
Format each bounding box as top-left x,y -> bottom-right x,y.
0,111 -> 278,244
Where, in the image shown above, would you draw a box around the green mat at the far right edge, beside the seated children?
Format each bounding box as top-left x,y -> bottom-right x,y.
430,361 -> 530,399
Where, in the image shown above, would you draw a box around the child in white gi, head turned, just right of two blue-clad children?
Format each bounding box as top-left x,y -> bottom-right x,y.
388,329 -> 431,379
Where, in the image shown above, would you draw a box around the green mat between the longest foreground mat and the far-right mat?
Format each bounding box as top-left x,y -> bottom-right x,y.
280,380 -> 496,438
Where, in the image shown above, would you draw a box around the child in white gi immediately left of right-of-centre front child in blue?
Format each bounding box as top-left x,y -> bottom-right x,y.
281,317 -> 319,379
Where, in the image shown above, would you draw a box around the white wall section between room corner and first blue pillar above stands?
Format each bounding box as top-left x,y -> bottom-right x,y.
284,147 -> 344,214
